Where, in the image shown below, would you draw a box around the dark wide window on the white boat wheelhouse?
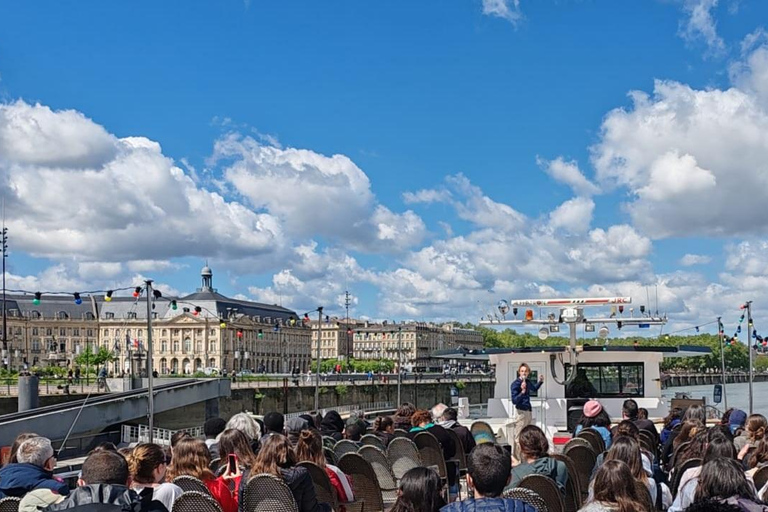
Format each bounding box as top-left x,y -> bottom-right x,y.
565,363 -> 645,398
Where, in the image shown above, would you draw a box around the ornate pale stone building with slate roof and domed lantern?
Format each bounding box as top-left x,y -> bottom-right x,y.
3,266 -> 311,374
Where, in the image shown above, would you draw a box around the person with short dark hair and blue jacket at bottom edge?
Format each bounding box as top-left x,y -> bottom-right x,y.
440,443 -> 536,512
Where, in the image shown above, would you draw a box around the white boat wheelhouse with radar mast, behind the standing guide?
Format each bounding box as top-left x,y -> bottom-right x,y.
438,297 -> 711,440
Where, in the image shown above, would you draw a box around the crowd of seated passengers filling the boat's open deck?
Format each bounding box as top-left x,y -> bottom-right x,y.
0,400 -> 768,512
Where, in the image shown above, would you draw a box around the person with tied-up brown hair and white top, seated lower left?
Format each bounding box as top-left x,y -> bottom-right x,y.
127,443 -> 184,510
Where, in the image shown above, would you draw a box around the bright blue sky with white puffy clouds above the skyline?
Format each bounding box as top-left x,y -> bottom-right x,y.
0,0 -> 768,340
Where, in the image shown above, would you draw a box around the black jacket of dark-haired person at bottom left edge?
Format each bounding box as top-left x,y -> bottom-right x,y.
45,484 -> 168,512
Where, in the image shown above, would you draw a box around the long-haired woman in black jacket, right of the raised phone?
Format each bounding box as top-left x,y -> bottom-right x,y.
248,434 -> 331,512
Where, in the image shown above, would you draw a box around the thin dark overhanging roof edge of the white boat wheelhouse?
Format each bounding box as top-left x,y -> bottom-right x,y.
432,345 -> 712,361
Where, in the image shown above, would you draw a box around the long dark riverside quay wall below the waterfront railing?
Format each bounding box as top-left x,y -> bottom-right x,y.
0,378 -> 495,431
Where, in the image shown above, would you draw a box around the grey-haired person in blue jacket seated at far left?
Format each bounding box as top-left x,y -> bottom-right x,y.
0,436 -> 69,504
